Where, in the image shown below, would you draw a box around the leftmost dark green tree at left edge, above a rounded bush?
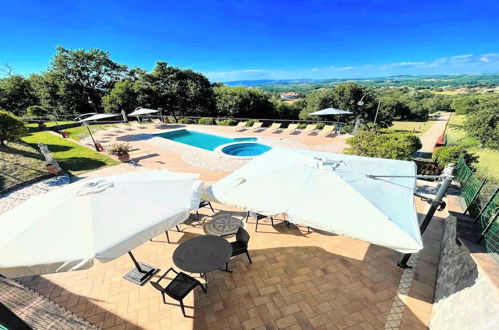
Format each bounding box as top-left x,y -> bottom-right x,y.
0,75 -> 38,116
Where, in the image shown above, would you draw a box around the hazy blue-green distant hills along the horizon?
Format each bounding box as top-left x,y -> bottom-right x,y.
225,74 -> 499,92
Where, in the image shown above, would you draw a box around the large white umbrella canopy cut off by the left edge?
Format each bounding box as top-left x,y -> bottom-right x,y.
0,171 -> 202,277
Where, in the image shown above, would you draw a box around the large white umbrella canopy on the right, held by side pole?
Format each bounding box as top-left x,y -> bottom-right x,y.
203,148 -> 422,253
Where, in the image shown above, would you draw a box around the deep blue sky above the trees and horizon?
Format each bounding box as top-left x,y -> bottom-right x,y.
0,0 -> 499,81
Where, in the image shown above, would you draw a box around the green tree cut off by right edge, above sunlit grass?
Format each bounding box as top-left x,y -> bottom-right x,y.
466,96 -> 499,149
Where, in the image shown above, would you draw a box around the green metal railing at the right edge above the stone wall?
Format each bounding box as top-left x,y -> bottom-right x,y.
456,158 -> 499,253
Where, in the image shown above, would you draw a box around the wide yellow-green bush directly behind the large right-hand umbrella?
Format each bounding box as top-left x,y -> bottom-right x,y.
345,130 -> 422,160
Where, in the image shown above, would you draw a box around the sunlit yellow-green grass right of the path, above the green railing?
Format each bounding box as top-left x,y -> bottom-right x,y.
446,114 -> 499,182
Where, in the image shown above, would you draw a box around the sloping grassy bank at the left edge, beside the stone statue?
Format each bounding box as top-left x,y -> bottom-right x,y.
0,141 -> 48,191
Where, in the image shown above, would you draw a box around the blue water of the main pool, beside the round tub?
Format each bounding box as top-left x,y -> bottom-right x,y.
157,129 -> 256,151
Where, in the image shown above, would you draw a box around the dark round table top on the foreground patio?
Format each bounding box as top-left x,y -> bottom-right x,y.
173,235 -> 232,273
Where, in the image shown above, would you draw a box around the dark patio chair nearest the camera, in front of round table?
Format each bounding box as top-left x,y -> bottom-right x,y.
151,268 -> 206,317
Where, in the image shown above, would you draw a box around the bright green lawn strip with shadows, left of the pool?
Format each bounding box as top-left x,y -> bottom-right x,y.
22,132 -> 118,174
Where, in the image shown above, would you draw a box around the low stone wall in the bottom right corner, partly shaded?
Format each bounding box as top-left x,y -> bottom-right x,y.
430,216 -> 499,330
